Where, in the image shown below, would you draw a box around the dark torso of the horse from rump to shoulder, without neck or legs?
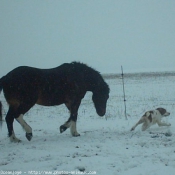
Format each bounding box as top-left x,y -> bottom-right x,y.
0,63 -> 82,106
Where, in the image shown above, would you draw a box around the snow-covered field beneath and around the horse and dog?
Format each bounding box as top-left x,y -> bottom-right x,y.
0,73 -> 175,175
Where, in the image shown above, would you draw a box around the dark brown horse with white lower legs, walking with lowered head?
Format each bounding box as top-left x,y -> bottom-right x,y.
0,62 -> 110,142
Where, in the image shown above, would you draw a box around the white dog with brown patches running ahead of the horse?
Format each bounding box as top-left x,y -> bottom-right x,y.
131,108 -> 171,131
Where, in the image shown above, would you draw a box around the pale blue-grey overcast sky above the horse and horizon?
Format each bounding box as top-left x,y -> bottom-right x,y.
0,0 -> 175,76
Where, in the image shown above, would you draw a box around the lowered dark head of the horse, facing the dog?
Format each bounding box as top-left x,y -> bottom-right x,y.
92,89 -> 109,116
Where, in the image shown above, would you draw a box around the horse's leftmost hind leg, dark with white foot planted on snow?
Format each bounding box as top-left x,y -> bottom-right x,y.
5,107 -> 20,142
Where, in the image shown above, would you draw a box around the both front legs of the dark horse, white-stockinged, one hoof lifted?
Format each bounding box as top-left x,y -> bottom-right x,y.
60,100 -> 81,137
